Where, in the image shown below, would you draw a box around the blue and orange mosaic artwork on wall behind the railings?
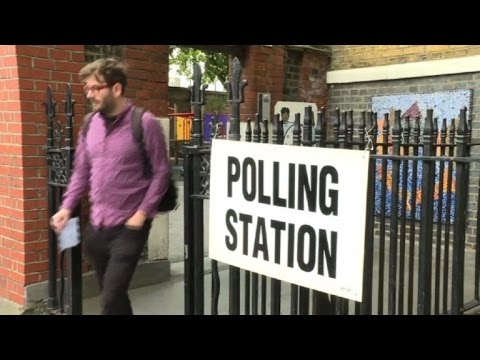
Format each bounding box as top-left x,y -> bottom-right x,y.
372,90 -> 473,224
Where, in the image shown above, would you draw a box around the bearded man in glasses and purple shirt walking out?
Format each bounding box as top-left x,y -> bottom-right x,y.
51,59 -> 170,315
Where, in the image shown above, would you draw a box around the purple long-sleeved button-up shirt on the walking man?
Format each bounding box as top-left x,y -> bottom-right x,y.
62,104 -> 170,228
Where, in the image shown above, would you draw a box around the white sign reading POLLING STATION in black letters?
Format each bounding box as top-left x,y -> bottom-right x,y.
209,140 -> 369,301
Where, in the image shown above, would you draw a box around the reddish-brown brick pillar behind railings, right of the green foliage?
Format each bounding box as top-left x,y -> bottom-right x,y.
240,45 -> 285,121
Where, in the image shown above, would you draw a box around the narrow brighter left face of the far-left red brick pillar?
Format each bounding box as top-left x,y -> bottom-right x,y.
0,45 -> 22,301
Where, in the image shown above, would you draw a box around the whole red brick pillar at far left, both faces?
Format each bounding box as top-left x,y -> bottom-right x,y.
0,45 -> 85,305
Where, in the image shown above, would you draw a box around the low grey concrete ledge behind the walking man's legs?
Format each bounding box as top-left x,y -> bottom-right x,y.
24,260 -> 170,306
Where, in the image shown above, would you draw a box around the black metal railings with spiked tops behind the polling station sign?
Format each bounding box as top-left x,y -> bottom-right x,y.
184,59 -> 480,315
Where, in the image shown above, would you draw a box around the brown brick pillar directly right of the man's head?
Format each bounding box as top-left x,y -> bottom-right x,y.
125,45 -> 168,117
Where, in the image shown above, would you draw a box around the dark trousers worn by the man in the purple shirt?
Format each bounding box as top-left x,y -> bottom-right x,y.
85,220 -> 152,315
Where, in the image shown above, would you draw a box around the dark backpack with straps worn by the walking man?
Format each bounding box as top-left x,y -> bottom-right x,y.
82,107 -> 178,212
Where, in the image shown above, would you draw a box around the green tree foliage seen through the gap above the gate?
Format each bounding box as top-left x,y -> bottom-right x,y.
169,45 -> 228,89
